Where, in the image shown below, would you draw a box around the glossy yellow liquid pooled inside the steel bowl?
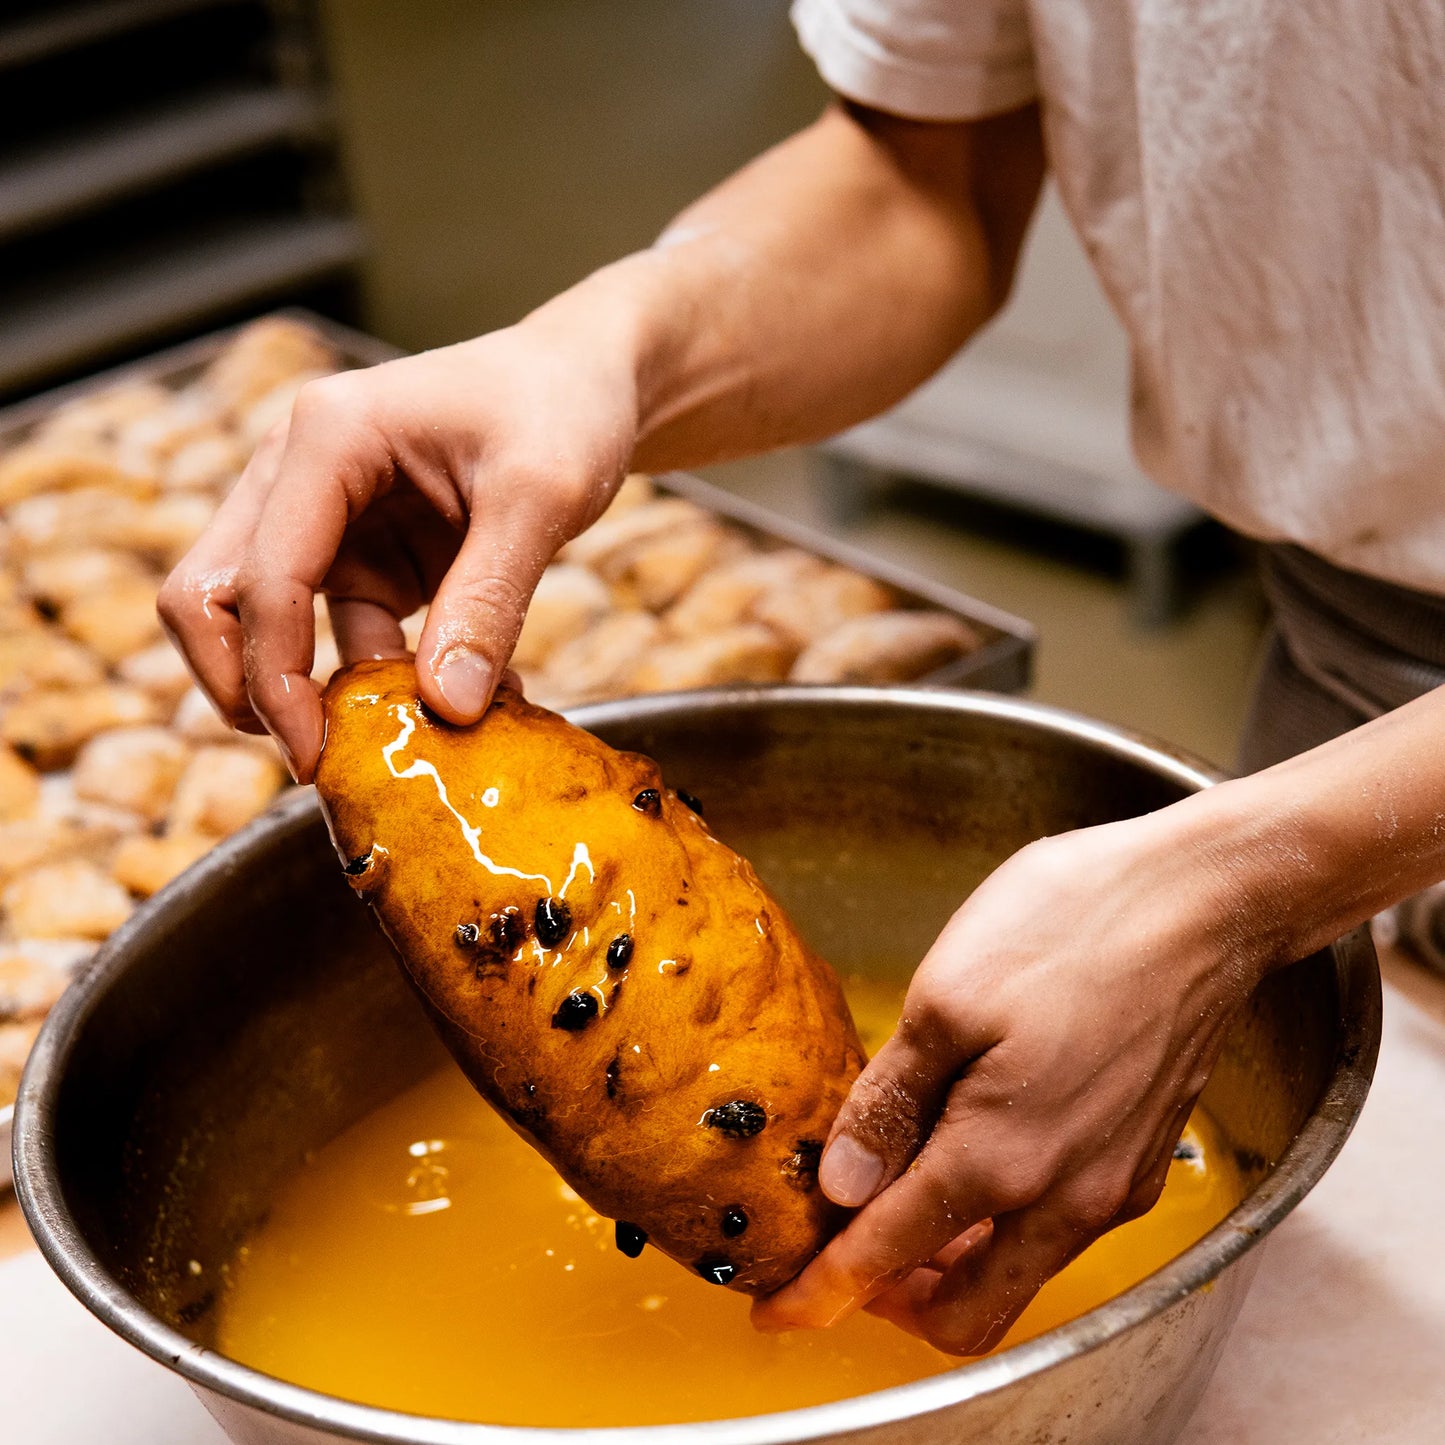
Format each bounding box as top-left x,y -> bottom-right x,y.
217,980 -> 1243,1426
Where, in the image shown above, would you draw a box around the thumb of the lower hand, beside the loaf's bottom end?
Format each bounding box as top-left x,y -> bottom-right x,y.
818,1019 -> 962,1209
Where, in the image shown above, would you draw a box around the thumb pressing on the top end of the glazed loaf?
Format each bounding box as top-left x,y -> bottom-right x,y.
416,513 -> 553,723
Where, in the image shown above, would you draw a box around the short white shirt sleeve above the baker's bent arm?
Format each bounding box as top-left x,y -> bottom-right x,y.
792,0 -> 1038,120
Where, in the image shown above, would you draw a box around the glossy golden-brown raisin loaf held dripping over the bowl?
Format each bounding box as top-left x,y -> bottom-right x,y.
316,662 -> 863,1295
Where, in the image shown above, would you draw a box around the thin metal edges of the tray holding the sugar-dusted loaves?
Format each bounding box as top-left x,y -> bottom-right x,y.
0,308 -> 1036,1191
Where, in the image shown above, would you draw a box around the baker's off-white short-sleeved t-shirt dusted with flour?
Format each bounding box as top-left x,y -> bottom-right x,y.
793,0 -> 1445,592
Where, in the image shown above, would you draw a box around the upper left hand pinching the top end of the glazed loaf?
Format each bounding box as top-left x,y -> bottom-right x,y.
159,319 -> 636,782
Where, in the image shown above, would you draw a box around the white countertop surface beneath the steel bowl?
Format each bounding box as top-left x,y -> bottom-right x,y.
0,961 -> 1445,1445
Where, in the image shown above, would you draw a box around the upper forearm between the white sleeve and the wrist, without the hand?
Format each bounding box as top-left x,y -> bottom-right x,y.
525,107 -> 1042,470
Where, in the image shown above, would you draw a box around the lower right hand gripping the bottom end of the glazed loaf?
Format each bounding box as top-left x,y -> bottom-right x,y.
754,789 -> 1263,1354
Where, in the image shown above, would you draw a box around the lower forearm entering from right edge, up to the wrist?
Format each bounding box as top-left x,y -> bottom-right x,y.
1179,689 -> 1445,970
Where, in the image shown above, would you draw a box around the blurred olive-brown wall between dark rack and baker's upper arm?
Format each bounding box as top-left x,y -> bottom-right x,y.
322,0 -> 827,347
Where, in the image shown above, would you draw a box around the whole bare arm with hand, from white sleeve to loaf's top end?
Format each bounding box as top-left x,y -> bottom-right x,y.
160,105 -> 1042,779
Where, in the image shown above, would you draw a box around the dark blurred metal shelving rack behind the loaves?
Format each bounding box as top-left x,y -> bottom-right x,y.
0,0 -> 363,394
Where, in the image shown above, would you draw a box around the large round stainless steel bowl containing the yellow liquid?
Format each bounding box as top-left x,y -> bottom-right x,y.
14,688 -> 1380,1445
